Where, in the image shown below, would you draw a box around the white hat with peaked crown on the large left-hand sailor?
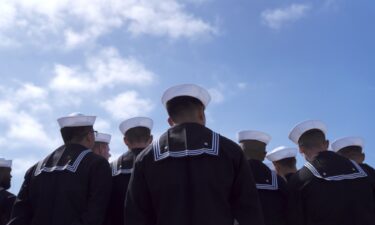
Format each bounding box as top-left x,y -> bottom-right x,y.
57,113 -> 96,128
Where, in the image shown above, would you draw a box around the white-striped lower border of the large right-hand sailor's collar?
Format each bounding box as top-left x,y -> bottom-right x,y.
304,160 -> 367,181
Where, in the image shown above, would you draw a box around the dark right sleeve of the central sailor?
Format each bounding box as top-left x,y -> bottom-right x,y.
231,152 -> 264,225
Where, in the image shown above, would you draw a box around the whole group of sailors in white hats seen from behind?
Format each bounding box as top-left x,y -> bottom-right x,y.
0,85 -> 375,225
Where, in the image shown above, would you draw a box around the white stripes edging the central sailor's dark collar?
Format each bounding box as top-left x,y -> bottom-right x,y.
153,132 -> 220,161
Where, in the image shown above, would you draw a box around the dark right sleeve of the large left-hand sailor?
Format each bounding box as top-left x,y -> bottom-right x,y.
73,160 -> 112,225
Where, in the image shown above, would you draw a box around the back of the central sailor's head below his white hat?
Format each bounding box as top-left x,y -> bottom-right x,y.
166,96 -> 204,123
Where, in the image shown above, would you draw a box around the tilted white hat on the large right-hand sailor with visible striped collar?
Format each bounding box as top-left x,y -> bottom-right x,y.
289,120 -> 327,144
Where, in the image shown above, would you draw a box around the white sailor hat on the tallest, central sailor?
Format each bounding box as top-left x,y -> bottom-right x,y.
161,84 -> 211,107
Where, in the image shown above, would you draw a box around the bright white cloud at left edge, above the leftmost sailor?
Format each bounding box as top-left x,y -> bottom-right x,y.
0,83 -> 55,149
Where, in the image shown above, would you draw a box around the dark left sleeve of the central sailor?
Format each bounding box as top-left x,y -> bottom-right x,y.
124,159 -> 155,225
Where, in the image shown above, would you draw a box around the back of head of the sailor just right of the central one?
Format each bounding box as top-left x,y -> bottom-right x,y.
240,140 -> 267,161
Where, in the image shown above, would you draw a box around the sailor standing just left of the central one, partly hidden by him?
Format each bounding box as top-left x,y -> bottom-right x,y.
106,117 -> 153,225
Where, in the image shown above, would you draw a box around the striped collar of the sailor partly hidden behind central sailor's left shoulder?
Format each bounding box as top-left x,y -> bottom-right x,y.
111,150 -> 135,177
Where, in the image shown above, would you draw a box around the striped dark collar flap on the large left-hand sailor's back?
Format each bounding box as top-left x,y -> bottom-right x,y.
34,145 -> 91,176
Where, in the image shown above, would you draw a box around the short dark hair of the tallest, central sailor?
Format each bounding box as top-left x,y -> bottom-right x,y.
167,96 -> 204,119
